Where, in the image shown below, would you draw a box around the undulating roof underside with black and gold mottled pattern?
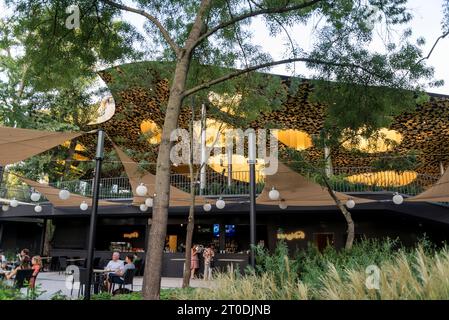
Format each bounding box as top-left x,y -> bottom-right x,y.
93,61 -> 449,179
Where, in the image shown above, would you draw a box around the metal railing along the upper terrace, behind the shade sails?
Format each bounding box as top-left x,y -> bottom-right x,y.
0,167 -> 439,202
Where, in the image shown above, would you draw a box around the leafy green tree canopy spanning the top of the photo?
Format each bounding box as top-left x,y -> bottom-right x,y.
2,0 -> 447,142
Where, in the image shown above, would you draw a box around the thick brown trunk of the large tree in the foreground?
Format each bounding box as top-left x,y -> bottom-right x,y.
142,55 -> 190,300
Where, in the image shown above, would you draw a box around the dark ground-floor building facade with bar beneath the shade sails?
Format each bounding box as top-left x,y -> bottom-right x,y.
0,196 -> 449,277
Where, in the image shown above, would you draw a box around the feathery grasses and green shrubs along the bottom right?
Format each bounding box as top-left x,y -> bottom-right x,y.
170,239 -> 449,300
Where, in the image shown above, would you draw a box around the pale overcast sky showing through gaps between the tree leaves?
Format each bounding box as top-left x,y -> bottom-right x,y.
0,0 -> 449,95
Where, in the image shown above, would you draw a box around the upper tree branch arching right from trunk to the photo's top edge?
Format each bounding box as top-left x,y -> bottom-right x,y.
195,0 -> 322,47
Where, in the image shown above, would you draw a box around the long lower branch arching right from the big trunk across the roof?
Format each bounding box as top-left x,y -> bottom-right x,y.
183,58 -> 382,97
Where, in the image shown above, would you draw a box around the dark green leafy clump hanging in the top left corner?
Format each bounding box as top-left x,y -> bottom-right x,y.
6,0 -> 139,91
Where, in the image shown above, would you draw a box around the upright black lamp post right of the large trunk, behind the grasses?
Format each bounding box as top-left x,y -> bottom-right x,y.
248,130 -> 256,268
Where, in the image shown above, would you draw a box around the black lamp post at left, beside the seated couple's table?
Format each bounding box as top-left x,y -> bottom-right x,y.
85,130 -> 104,300
